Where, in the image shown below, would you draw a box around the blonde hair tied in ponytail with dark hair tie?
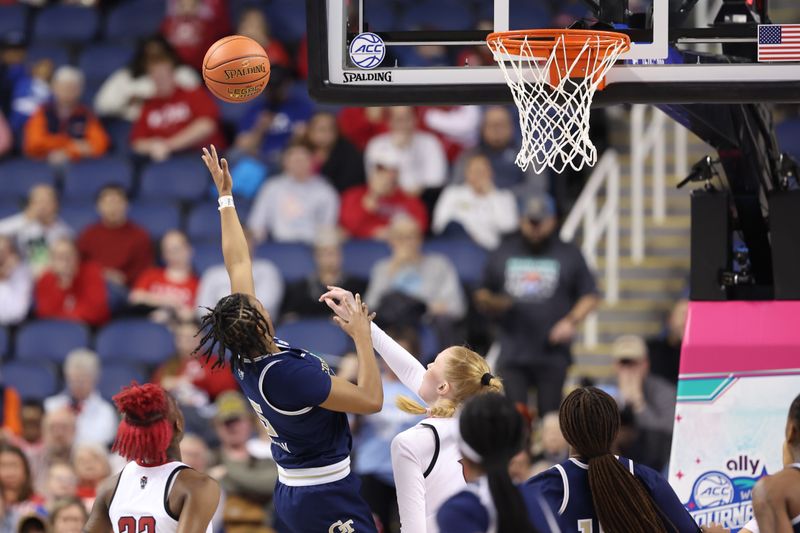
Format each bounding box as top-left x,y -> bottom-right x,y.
395,346 -> 503,418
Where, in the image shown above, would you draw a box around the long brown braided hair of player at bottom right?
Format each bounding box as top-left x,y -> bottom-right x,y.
558,387 -> 677,533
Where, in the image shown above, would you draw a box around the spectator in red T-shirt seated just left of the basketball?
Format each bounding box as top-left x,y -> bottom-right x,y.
131,57 -> 225,161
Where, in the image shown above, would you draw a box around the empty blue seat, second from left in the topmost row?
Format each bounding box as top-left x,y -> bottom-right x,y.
33,5 -> 100,44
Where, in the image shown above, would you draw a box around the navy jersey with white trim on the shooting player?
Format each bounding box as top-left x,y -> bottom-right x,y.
234,339 -> 352,469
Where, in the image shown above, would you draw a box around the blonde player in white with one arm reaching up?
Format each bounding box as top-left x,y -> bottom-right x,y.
320,287 -> 503,533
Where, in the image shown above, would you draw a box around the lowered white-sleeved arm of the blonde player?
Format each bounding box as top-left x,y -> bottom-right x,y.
392,428 -> 433,533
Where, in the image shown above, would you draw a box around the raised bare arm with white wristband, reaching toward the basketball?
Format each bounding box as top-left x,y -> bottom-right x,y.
203,144 -> 255,296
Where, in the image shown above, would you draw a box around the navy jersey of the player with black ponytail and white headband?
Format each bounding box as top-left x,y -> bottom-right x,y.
436,478 -> 562,533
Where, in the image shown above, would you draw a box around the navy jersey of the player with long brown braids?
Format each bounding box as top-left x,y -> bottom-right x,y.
522,457 -> 700,533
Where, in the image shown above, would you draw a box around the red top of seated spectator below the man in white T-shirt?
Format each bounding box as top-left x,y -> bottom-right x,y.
339,185 -> 428,239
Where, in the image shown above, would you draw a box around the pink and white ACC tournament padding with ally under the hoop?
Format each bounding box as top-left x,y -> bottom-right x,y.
669,302 -> 800,532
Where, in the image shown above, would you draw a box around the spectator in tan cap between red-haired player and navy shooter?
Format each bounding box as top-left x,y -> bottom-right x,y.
209,392 -> 278,532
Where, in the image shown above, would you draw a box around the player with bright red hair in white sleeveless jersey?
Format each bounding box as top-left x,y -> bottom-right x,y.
84,383 -> 220,533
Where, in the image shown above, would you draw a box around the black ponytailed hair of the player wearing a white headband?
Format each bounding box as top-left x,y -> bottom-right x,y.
458,393 -> 535,533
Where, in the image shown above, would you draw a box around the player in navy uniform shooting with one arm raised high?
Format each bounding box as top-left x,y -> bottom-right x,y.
196,146 -> 383,533
